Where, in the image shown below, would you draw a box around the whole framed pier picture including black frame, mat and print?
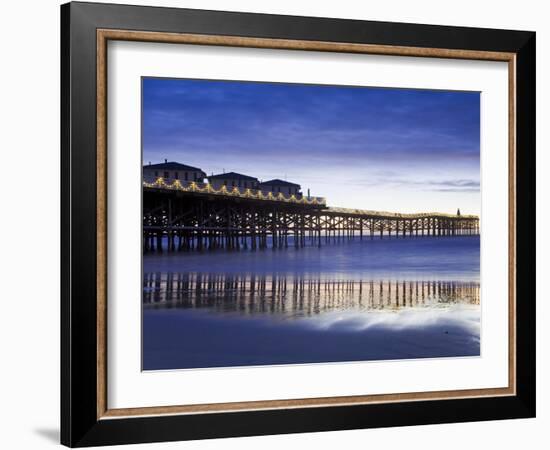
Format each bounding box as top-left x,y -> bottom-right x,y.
61,3 -> 535,447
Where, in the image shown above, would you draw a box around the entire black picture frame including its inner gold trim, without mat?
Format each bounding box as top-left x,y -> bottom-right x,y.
61,2 -> 536,447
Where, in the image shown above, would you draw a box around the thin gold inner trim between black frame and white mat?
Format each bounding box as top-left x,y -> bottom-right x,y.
97,29 -> 516,420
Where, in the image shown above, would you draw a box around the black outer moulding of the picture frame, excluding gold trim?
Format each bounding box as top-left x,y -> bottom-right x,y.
61,3 -> 535,447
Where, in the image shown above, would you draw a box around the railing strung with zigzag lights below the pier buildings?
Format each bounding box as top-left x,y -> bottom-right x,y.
143,177 -> 326,206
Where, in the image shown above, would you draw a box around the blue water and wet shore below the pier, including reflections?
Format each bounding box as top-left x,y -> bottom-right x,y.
142,236 -> 481,370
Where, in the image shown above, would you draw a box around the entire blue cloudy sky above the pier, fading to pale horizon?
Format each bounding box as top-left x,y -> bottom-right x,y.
142,78 -> 481,214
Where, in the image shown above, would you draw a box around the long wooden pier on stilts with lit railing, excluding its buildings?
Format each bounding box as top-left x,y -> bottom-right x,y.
143,179 -> 479,252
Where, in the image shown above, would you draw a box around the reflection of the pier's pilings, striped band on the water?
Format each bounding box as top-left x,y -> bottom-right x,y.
143,272 -> 479,316
